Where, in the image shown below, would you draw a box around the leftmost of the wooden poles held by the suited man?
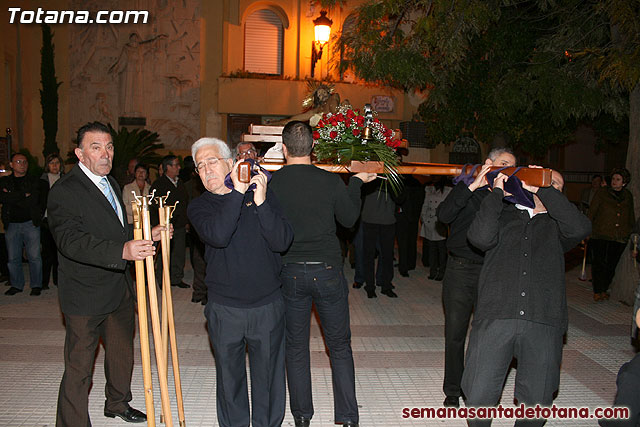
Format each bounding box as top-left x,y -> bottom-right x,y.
131,201 -> 156,427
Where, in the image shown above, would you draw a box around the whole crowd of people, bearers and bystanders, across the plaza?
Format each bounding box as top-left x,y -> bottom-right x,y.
0,121 -> 640,427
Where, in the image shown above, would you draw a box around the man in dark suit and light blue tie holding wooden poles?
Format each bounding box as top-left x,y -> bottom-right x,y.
47,122 -> 166,427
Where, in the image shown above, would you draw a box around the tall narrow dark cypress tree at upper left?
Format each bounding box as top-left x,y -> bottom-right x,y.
40,24 -> 62,157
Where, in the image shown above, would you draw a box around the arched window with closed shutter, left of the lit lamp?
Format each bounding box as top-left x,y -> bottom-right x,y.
244,9 -> 284,74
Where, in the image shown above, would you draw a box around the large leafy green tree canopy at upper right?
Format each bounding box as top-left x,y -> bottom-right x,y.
340,0 -> 640,157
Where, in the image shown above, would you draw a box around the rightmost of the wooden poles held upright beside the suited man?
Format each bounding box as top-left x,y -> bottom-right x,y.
161,202 -> 186,427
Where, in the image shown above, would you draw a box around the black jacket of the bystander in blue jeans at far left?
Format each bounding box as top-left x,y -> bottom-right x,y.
0,174 -> 48,228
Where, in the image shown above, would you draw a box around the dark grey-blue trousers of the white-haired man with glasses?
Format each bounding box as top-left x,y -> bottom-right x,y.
205,298 -> 286,427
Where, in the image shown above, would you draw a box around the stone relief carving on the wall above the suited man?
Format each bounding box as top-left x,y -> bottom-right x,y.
69,0 -> 202,149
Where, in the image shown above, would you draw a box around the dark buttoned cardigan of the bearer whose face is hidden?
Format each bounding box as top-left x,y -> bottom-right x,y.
468,187 -> 591,331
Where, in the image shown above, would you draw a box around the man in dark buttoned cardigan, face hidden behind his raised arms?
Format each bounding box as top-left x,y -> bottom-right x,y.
462,171 -> 591,426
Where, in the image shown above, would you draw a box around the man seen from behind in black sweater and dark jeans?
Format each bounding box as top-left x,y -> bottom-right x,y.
270,121 -> 376,427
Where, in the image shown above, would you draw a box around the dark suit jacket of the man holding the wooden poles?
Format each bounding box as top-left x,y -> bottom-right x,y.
47,165 -> 133,316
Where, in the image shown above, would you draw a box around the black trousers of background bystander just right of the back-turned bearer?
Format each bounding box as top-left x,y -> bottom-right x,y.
362,222 -> 395,291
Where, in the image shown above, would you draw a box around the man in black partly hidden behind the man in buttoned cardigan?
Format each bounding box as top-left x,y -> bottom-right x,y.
436,148 -> 516,406
